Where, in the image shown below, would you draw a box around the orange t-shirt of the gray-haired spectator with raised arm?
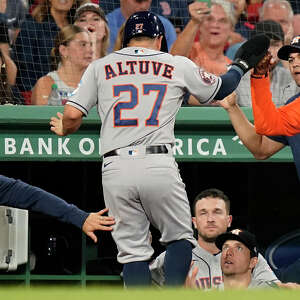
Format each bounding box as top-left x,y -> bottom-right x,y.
190,42 -> 231,76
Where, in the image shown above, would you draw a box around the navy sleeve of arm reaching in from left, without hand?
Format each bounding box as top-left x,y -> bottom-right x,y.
0,175 -> 88,229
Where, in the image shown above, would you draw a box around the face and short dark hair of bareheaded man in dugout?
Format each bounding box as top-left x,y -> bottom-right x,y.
193,197 -> 232,243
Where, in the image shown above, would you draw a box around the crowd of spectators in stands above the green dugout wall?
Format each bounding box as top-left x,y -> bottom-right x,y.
0,0 -> 300,106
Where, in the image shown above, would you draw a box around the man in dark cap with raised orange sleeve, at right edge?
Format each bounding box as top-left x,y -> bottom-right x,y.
251,36 -> 300,136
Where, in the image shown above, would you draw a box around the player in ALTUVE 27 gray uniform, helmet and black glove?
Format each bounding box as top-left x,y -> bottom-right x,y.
50,11 -> 269,286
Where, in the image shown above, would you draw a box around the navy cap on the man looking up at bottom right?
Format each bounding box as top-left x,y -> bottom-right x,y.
215,229 -> 258,257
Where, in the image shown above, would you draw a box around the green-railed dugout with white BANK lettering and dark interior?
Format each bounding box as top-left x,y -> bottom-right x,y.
0,106 -> 300,285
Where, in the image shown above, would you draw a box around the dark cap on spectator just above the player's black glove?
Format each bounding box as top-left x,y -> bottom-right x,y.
251,20 -> 284,41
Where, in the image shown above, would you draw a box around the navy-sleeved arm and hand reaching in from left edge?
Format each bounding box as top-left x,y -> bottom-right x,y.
0,175 -> 115,243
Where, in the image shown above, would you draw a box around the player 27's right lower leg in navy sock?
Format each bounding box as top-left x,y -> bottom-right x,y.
164,240 -> 193,286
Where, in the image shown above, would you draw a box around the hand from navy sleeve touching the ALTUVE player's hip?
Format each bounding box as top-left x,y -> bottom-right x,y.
82,208 -> 115,243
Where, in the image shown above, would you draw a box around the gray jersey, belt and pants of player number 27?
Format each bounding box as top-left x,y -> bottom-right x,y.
67,47 -> 221,263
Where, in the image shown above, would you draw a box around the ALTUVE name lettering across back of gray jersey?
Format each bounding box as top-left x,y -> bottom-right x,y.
104,60 -> 174,80
